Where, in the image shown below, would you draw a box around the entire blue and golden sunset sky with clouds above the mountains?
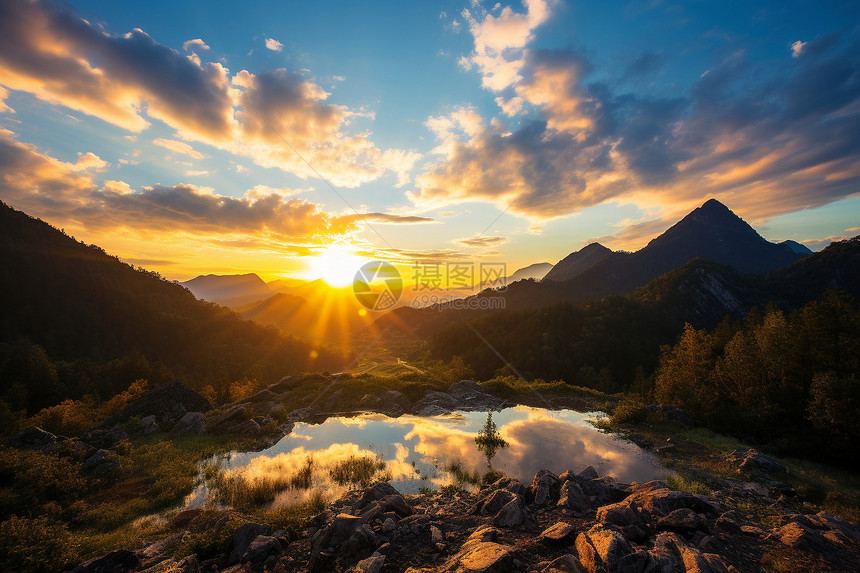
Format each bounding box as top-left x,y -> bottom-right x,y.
0,0 -> 860,280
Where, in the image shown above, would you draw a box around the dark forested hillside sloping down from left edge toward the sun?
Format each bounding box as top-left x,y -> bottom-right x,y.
0,203 -> 342,410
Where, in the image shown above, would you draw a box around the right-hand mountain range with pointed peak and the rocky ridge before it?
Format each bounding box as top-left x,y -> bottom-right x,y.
377,199 -> 860,337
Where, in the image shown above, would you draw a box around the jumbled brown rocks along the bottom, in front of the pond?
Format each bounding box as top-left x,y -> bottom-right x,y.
74,467 -> 860,573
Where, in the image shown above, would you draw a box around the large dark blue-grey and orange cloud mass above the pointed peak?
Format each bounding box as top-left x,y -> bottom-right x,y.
407,13 -> 860,226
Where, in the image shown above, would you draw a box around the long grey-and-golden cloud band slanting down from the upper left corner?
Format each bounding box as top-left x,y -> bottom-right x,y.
0,0 -> 416,187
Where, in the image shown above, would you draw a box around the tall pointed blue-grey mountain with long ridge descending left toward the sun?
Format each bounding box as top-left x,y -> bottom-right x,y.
378,199 -> 812,336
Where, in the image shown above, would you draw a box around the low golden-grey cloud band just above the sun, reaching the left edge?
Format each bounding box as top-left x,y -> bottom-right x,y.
0,129 -> 432,244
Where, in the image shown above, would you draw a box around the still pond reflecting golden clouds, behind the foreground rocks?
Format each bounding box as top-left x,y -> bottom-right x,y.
186,406 -> 668,507
